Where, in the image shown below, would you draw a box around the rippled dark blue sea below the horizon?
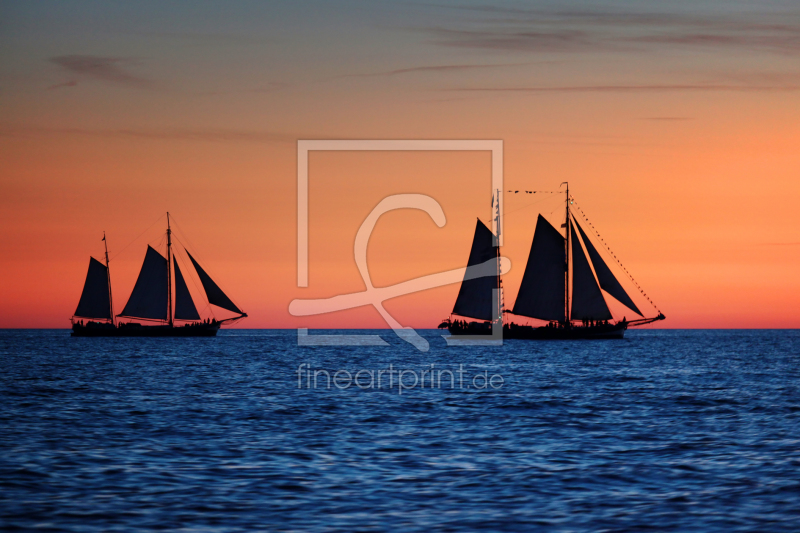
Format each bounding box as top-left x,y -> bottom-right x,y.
0,330 -> 800,532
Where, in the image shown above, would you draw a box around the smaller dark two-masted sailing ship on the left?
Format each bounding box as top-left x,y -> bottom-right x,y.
71,213 -> 247,337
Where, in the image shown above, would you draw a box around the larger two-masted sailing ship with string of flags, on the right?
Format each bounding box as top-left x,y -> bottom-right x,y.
439,183 -> 665,339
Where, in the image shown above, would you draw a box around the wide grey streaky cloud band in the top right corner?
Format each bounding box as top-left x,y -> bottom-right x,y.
423,6 -> 800,53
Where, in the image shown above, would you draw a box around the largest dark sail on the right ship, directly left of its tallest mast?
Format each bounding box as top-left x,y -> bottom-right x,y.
512,215 -> 566,320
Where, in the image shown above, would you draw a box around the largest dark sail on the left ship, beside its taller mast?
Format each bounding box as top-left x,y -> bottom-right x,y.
118,246 -> 168,320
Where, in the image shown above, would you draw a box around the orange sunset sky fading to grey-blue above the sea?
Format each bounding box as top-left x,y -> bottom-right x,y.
0,0 -> 800,328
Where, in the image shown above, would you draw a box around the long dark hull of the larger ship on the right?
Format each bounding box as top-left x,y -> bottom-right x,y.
447,322 -> 628,340
